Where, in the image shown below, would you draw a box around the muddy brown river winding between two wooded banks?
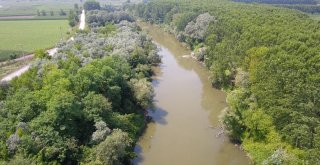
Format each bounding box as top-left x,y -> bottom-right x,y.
133,23 -> 249,165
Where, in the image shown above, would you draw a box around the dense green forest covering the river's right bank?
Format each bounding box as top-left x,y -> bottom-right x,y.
127,0 -> 320,164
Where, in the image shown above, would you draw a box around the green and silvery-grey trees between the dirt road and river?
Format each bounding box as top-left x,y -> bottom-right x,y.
0,5 -> 160,165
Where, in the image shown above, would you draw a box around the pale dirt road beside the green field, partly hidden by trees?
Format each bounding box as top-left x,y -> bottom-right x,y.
0,10 -> 86,82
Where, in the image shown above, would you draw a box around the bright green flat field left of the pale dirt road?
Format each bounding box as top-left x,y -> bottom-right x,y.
0,20 -> 69,61
